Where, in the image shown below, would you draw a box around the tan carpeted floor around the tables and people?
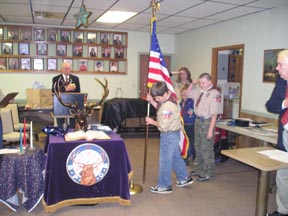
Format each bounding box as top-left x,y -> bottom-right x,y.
0,134 -> 276,216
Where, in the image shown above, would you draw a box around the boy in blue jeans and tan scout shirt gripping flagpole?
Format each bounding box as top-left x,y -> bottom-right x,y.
146,82 -> 193,194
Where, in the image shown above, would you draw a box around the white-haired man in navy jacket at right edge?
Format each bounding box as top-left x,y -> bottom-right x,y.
266,50 -> 288,216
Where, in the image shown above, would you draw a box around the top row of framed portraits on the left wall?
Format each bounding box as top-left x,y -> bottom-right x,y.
0,26 -> 126,45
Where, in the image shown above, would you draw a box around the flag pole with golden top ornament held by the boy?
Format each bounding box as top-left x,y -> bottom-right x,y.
142,0 -> 160,184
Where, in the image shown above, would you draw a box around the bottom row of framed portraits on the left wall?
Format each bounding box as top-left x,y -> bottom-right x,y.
0,58 -> 119,72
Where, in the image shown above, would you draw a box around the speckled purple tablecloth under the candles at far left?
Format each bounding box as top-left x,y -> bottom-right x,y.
0,149 -> 45,212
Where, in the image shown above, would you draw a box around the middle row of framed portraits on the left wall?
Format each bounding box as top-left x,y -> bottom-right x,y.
2,42 -> 126,58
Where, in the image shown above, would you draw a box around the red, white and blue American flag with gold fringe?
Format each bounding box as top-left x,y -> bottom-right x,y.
147,18 -> 189,158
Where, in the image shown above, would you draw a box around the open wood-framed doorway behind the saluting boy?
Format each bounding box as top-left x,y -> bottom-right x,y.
211,44 -> 245,118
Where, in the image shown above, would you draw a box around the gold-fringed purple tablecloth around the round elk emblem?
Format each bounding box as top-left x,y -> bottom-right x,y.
43,133 -> 132,212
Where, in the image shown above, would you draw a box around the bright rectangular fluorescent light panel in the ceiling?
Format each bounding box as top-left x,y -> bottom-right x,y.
96,11 -> 137,23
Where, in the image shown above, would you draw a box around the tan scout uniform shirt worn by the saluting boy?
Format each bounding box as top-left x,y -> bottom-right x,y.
194,87 -> 220,119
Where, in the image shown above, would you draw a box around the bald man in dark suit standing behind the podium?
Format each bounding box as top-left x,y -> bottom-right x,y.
52,62 -> 81,128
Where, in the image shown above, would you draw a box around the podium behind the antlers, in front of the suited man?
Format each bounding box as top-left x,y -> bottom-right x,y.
52,93 -> 88,126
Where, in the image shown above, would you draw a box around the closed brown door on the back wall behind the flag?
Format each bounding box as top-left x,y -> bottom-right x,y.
139,54 -> 171,98
